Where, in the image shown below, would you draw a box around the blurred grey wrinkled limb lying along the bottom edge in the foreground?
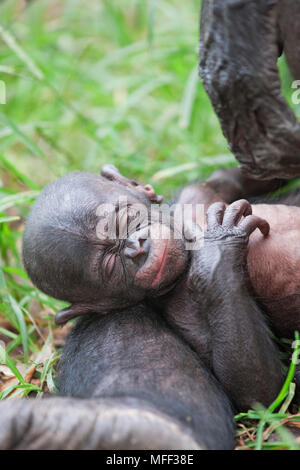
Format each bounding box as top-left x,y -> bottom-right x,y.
0,397 -> 200,450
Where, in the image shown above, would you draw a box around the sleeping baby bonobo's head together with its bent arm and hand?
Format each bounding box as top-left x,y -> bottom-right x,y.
24,165 -> 281,410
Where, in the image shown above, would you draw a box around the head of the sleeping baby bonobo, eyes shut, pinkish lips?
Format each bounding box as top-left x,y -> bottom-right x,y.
23,165 -> 188,323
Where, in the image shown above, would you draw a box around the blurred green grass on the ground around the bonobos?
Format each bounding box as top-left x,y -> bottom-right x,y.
0,0 -> 299,448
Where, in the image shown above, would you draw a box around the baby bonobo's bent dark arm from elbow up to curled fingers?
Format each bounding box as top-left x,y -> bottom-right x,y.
188,200 -> 282,410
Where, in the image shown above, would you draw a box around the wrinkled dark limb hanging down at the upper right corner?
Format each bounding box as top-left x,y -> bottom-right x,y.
200,0 -> 300,180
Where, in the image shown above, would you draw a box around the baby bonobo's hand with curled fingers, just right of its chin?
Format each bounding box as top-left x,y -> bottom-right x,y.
188,199 -> 270,296
